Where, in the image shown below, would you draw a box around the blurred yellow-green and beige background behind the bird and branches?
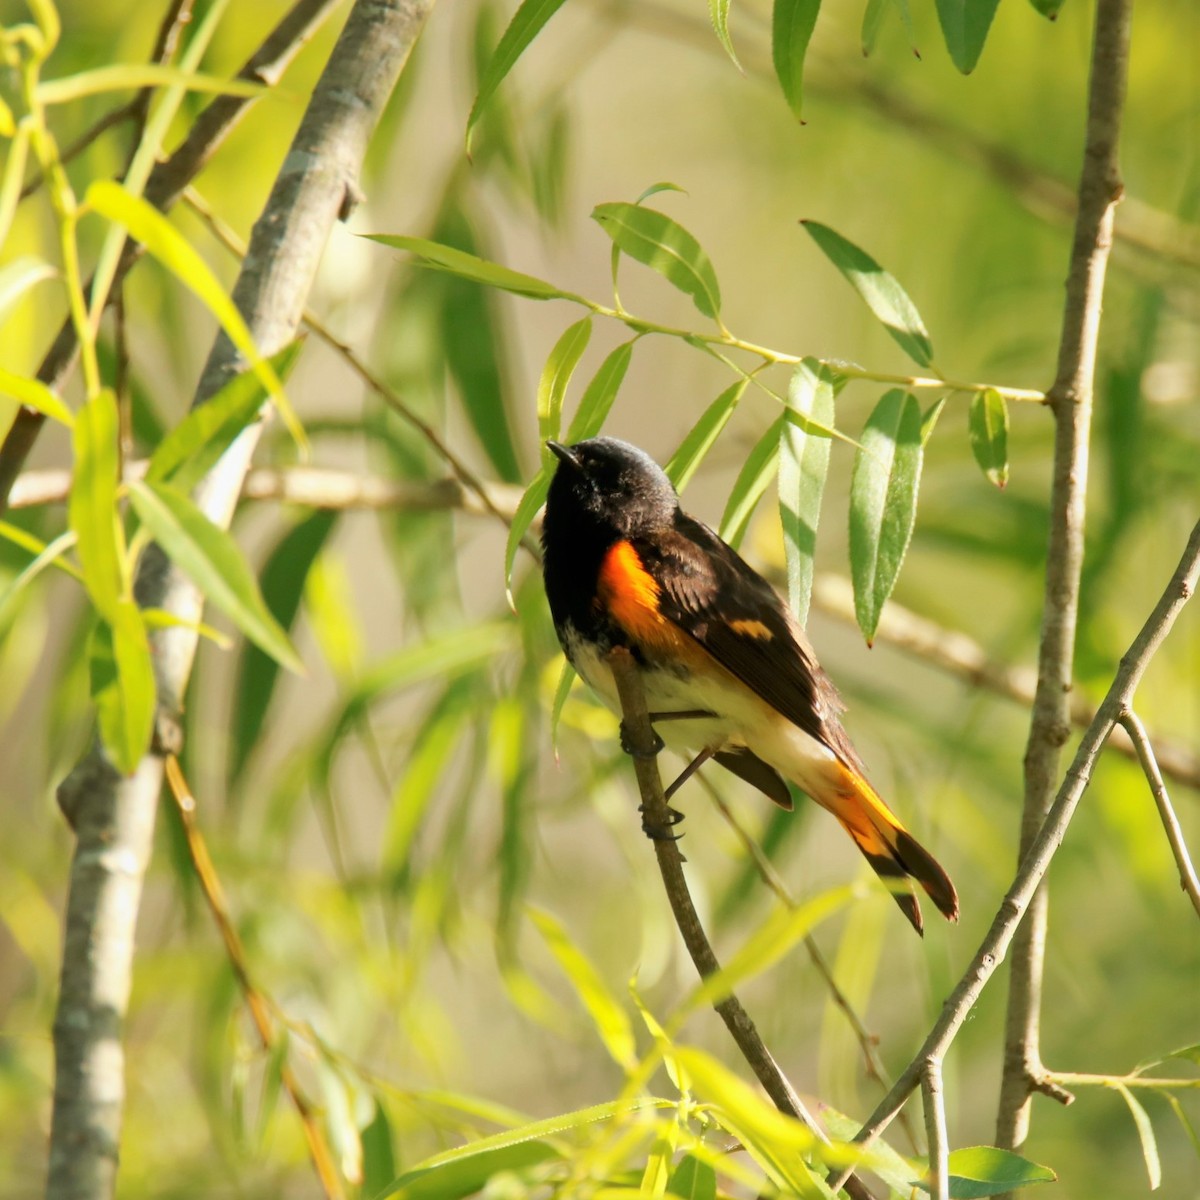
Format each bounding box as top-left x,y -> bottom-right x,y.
0,0 -> 1200,1200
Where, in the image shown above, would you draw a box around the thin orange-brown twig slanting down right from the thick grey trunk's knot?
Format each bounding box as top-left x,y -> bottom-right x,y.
166,755 -> 342,1200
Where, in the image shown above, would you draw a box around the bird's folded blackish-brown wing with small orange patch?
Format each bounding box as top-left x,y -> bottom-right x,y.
635,512 -> 862,769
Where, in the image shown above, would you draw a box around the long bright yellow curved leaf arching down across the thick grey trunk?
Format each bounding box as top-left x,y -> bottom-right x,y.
85,179 -> 308,452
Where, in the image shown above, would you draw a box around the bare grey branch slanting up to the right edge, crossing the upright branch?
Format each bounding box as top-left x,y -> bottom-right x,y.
830,522 -> 1200,1200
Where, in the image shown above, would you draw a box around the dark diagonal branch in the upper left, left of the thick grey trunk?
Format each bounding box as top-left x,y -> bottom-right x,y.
0,0 -> 338,514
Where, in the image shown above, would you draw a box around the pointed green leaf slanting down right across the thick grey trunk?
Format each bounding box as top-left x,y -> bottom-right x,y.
128,481 -> 305,674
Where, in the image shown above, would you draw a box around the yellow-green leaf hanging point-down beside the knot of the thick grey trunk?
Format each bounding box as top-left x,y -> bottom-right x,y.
89,599 -> 156,775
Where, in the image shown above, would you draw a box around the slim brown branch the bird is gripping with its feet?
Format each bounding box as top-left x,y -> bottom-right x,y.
608,646 -> 870,1200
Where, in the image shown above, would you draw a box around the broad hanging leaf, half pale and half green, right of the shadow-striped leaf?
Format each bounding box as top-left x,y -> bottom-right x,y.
850,389 -> 923,644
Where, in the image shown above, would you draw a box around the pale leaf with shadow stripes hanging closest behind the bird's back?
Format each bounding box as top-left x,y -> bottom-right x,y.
779,359 -> 838,626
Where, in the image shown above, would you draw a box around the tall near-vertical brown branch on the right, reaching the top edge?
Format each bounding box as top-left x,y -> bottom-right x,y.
996,0 -> 1133,1150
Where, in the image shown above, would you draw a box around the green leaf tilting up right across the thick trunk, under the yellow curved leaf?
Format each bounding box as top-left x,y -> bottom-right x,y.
145,340 -> 304,492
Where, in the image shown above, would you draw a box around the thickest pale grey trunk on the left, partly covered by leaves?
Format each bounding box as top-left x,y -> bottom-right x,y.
48,0 -> 432,1200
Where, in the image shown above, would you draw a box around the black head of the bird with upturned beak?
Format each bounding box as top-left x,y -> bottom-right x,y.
544,438 -> 679,546
